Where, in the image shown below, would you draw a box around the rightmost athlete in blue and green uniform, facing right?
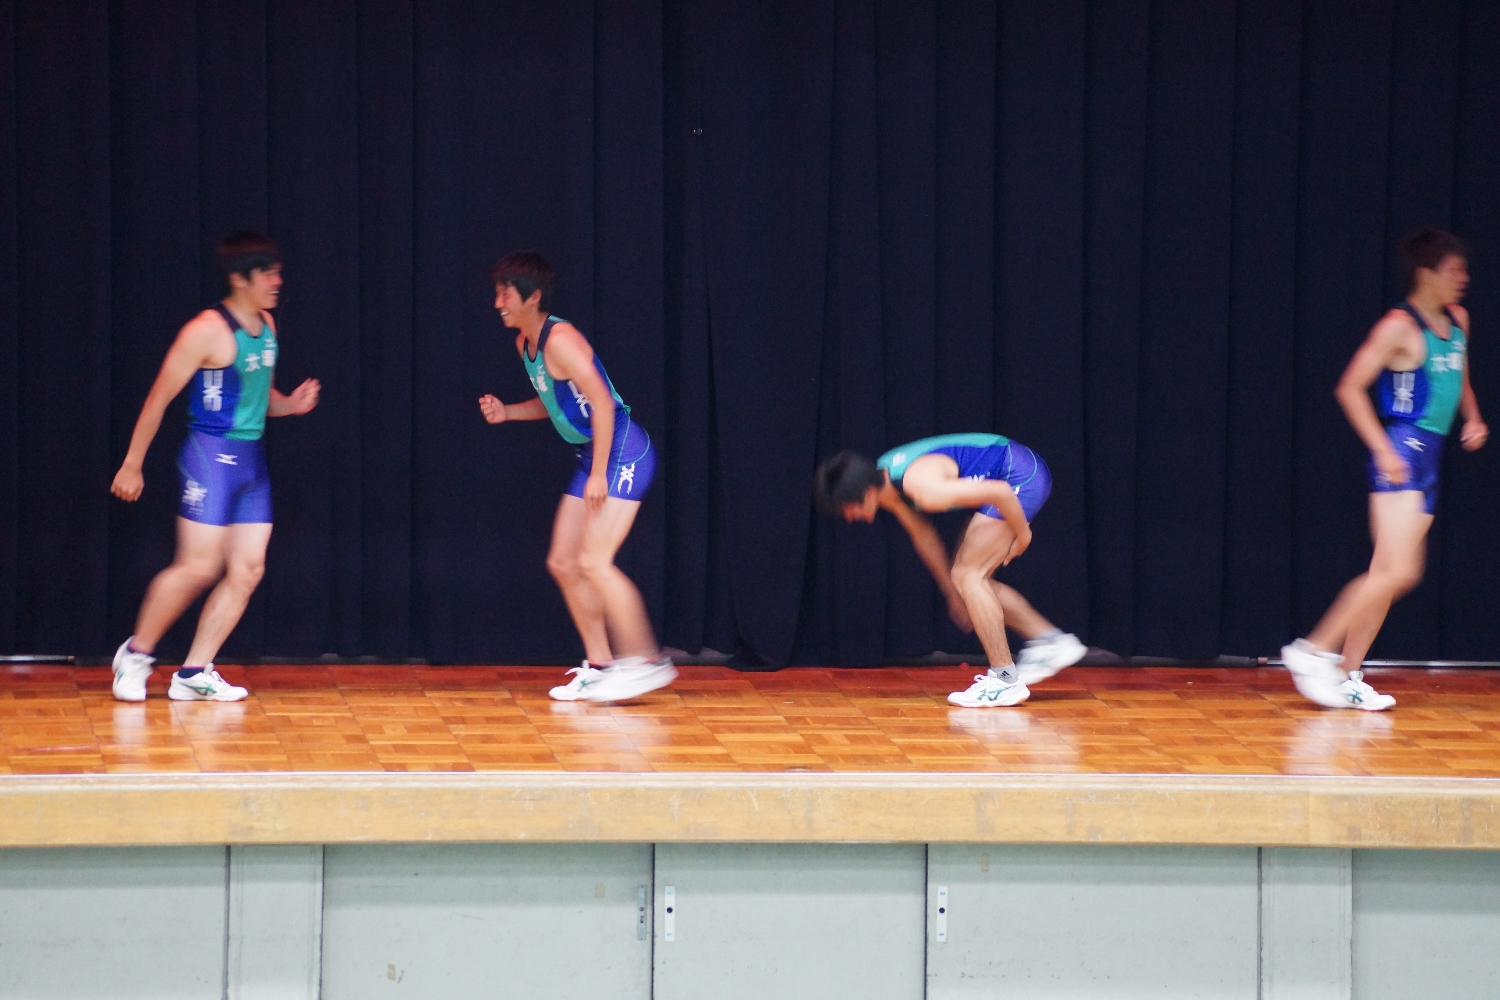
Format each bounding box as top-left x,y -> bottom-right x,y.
1281,229 -> 1490,711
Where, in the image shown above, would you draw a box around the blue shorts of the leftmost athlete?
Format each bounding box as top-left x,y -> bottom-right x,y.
177,430 -> 272,525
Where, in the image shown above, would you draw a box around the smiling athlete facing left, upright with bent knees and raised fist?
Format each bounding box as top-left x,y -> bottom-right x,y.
479,253 -> 677,702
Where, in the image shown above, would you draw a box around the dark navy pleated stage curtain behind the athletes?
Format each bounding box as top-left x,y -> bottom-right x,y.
0,0 -> 1500,664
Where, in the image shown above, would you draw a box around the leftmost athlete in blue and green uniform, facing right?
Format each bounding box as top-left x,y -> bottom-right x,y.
110,232 -> 320,702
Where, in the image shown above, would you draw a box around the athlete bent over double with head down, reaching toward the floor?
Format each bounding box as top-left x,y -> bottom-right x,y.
813,433 -> 1088,708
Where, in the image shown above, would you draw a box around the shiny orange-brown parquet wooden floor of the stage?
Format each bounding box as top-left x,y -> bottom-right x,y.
0,666 -> 1500,777
